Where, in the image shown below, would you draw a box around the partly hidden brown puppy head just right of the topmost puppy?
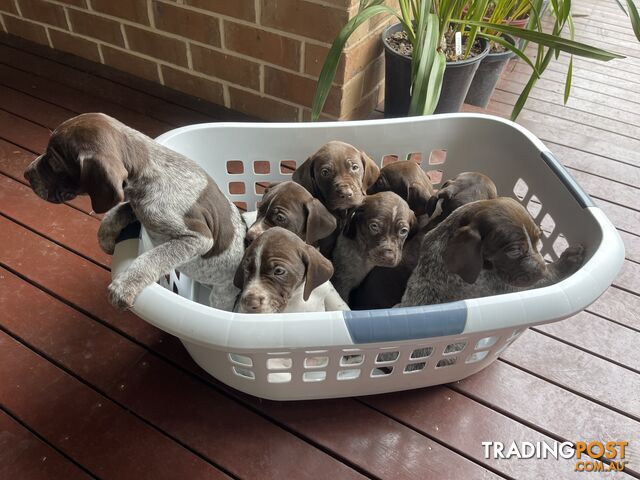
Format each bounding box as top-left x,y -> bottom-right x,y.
367,161 -> 436,216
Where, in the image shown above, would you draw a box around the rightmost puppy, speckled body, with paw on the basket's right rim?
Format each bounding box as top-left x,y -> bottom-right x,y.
400,197 -> 584,307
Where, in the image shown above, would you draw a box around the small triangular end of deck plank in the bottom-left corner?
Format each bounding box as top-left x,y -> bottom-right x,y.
0,410 -> 92,480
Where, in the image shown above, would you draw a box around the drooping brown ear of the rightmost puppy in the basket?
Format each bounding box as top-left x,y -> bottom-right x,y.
443,225 -> 483,283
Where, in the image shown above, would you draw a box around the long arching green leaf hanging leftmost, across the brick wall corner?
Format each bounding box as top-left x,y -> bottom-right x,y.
311,1 -> 397,121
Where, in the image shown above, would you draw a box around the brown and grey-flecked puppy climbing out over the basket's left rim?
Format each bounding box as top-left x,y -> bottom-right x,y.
25,113 -> 246,310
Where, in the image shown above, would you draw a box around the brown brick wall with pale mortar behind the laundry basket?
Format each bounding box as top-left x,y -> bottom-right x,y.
0,0 -> 384,121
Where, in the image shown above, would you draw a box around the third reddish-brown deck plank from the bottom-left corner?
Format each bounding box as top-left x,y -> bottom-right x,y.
0,271 -> 368,479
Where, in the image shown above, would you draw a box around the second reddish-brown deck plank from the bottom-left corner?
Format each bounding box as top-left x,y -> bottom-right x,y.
0,332 -> 227,479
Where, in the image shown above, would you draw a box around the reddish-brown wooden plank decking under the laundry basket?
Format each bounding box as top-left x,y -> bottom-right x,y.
0,0 -> 640,474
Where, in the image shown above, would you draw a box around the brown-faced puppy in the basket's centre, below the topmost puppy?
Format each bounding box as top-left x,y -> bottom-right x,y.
333,192 -> 416,302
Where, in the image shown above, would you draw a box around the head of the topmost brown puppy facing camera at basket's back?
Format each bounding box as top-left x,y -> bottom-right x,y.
293,141 -> 380,213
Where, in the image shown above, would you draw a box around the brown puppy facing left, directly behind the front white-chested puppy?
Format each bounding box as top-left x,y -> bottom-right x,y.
243,181 -> 337,245
